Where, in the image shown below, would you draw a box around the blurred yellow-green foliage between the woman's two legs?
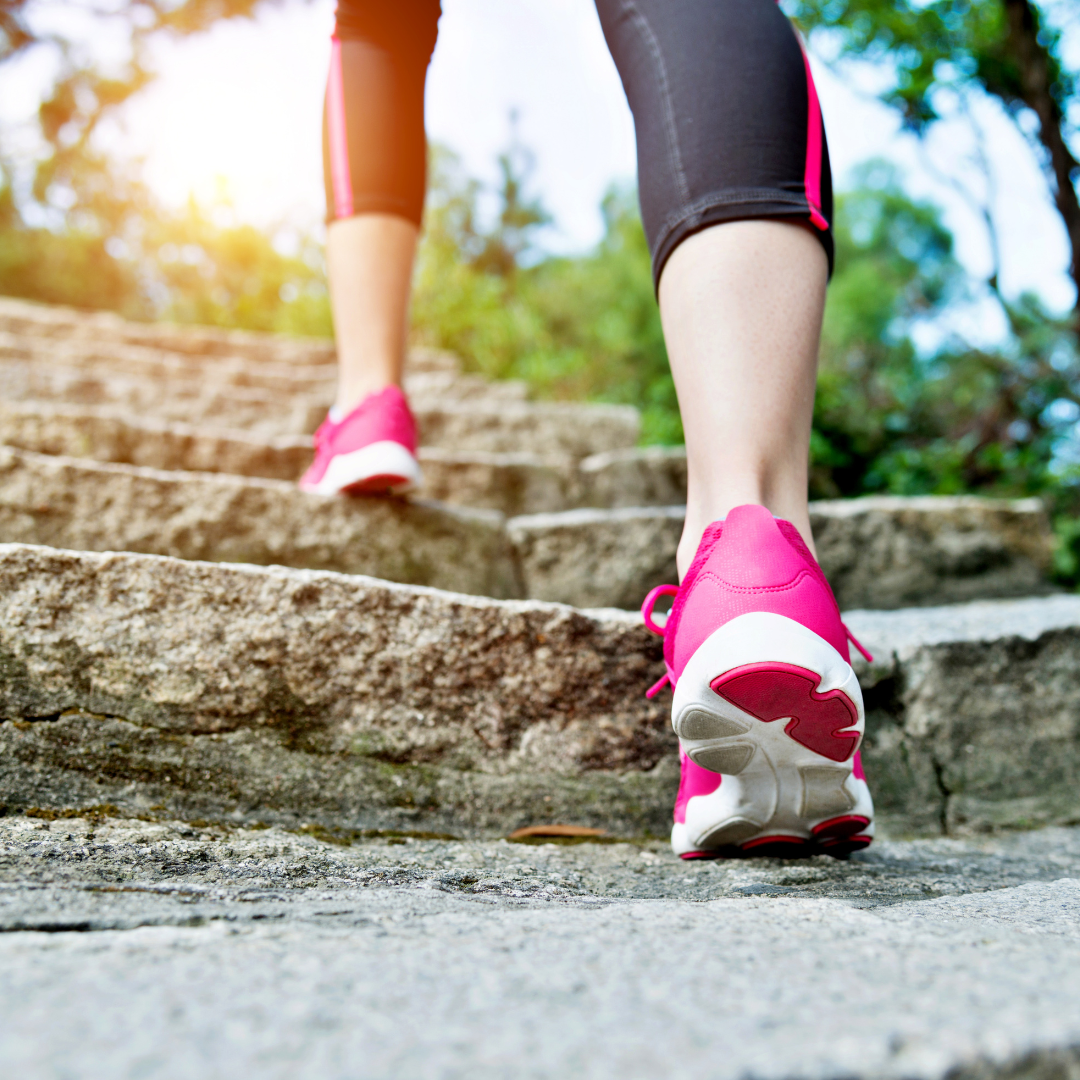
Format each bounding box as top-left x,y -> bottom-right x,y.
413,148 -> 681,442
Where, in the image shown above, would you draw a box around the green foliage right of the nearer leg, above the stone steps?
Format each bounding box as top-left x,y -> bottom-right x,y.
811,163 -> 1080,511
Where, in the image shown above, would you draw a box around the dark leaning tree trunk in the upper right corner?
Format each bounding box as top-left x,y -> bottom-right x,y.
1002,0 -> 1080,318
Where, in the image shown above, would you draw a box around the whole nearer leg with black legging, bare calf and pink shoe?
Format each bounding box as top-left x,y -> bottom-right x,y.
596,0 -> 874,859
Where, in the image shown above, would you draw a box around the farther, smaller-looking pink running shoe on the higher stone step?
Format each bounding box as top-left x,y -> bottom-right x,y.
300,387 -> 420,495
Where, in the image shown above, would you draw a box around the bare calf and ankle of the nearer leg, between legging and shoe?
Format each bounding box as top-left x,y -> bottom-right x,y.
660,220 -> 828,577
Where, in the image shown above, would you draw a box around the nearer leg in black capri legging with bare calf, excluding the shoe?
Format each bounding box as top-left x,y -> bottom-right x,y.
596,0 -> 833,573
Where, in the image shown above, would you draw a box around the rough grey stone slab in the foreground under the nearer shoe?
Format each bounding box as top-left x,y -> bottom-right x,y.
0,812 -> 1080,1080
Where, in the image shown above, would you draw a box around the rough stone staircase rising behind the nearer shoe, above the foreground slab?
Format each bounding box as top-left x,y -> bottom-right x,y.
0,300 -> 1080,836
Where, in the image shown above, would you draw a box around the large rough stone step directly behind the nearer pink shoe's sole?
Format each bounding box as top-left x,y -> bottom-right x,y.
0,544 -> 1080,836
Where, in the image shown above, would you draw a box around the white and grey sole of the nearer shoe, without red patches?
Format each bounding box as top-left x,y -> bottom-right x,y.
672,611 -> 874,854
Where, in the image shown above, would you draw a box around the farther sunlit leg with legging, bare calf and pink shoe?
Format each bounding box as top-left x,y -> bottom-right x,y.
300,0 -> 440,495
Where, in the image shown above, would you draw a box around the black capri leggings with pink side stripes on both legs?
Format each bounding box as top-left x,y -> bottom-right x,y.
323,0 -> 833,283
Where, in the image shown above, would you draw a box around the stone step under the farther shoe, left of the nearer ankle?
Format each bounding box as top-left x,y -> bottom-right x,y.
0,442 -> 669,608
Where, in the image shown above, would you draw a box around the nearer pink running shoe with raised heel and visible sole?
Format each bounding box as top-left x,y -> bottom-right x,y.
642,505 -> 874,859
